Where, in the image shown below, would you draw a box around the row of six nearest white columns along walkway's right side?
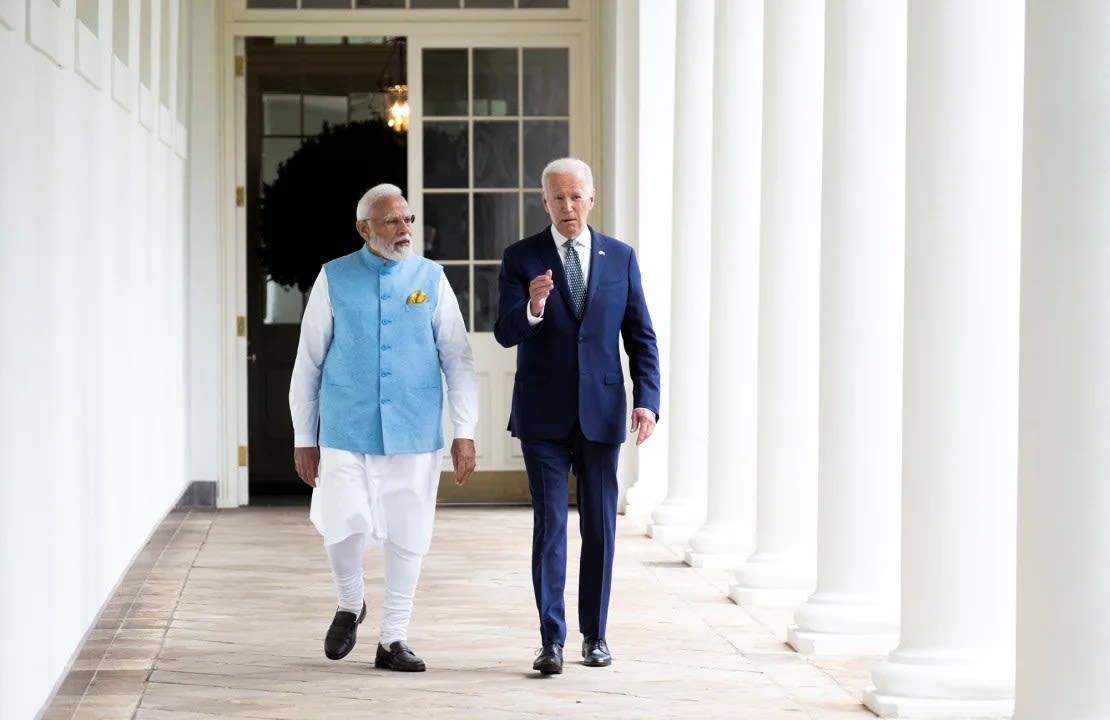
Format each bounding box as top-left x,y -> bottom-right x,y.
634,0 -> 1110,720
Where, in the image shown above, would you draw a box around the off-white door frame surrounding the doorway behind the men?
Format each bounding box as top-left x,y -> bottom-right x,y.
216,0 -> 604,508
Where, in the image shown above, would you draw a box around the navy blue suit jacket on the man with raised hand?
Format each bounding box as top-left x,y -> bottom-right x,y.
494,227 -> 659,444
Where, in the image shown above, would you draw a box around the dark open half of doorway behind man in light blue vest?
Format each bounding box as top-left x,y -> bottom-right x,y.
244,37 -> 408,504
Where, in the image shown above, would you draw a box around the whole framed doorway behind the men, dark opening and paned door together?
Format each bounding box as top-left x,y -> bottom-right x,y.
227,9 -> 602,505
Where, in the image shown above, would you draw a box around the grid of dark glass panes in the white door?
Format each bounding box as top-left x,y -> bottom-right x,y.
421,48 -> 571,333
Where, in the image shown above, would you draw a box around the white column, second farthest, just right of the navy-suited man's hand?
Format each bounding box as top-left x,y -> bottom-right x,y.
647,0 -> 714,542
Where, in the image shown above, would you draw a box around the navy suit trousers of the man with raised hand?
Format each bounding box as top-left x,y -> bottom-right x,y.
521,428 -> 620,646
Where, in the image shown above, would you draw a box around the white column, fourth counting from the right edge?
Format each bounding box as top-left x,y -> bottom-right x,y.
729,0 -> 825,605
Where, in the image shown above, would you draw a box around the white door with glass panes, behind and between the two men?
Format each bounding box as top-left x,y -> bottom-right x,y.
408,33 -> 589,472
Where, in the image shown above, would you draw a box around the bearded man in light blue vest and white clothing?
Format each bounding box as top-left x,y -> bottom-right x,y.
290,184 -> 478,672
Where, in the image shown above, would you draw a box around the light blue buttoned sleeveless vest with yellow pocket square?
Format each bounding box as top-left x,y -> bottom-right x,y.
320,245 -> 443,455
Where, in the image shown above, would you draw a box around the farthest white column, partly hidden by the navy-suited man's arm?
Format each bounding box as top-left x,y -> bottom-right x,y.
617,0 -> 676,525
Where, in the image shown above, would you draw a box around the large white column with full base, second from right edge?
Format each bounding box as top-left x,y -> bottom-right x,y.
864,0 -> 1025,718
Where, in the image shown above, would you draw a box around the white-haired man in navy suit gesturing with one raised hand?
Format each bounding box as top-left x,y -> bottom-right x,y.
494,158 -> 659,675
